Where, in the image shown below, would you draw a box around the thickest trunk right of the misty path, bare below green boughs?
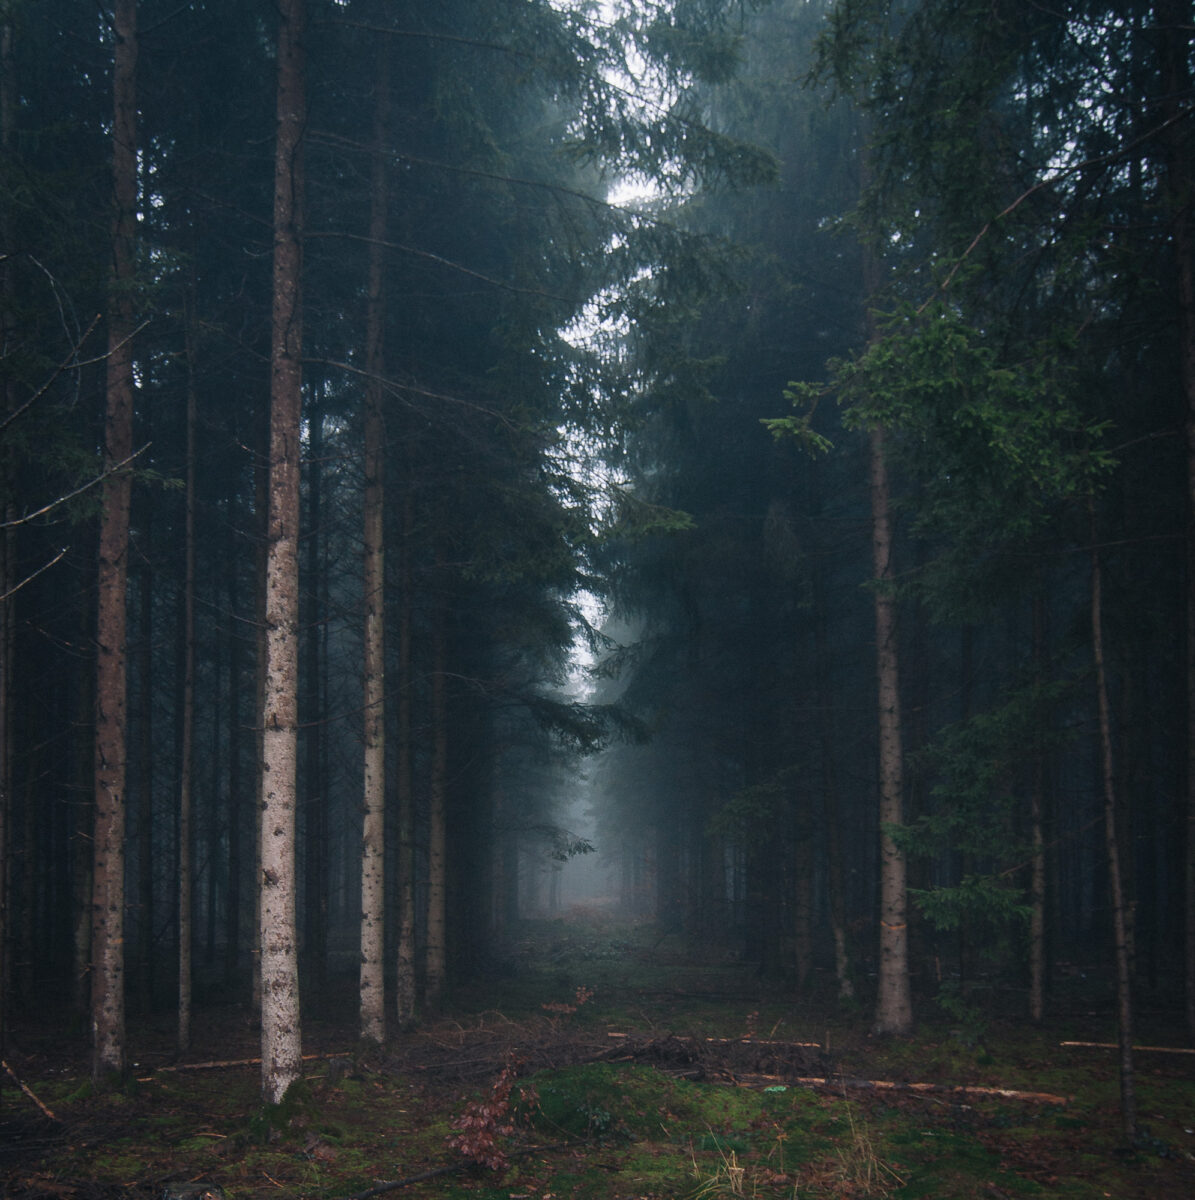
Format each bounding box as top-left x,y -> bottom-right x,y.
870,425 -> 913,1033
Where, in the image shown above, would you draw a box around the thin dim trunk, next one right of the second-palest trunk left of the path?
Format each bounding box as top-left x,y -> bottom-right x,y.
395,488 -> 418,1030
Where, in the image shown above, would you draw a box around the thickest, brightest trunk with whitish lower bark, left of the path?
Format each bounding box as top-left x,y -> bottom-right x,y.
259,0 -> 306,1104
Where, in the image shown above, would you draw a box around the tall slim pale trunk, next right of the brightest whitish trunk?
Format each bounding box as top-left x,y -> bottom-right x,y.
360,38 -> 390,1043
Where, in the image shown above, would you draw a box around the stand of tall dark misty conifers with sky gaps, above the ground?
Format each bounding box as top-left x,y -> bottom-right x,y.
0,0 -> 1195,1195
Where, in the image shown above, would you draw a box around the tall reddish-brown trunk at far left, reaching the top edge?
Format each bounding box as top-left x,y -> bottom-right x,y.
91,0 -> 137,1085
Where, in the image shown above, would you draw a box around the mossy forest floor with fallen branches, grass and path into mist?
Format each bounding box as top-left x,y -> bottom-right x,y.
0,914 -> 1195,1200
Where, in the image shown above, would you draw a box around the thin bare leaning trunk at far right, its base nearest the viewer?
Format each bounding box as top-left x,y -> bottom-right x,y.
1092,535 -> 1137,1146
